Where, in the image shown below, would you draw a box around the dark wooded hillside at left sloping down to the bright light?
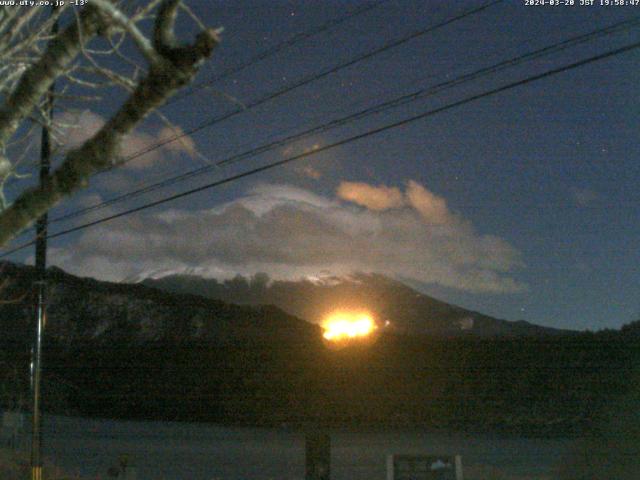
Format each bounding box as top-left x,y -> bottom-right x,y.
0,262 -> 320,345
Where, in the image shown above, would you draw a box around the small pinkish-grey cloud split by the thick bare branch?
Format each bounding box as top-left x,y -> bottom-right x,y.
57,110 -> 196,169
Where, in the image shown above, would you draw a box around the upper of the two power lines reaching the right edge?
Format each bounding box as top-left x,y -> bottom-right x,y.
51,17 -> 640,223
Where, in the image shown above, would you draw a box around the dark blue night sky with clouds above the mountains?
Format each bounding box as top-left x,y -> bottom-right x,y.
1,0 -> 640,330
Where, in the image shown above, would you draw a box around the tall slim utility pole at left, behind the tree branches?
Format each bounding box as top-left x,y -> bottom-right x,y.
31,6 -> 58,480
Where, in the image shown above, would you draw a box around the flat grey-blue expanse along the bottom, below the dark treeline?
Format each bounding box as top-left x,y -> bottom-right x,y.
12,415 -> 574,480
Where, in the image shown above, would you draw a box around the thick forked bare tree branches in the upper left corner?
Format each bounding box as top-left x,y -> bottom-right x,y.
0,0 -> 220,246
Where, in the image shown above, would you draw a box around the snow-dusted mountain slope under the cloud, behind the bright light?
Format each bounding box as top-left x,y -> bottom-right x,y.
142,273 -> 568,336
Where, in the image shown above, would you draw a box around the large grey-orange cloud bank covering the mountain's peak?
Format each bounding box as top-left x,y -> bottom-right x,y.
51,182 -> 525,293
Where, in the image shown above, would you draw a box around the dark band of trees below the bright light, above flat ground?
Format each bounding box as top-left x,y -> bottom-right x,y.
4,325 -> 640,435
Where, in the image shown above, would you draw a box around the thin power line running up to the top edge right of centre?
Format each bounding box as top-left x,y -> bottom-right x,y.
96,0 -> 504,175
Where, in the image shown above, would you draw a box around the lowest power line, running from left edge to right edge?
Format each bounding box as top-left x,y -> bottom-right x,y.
0,42 -> 640,258
